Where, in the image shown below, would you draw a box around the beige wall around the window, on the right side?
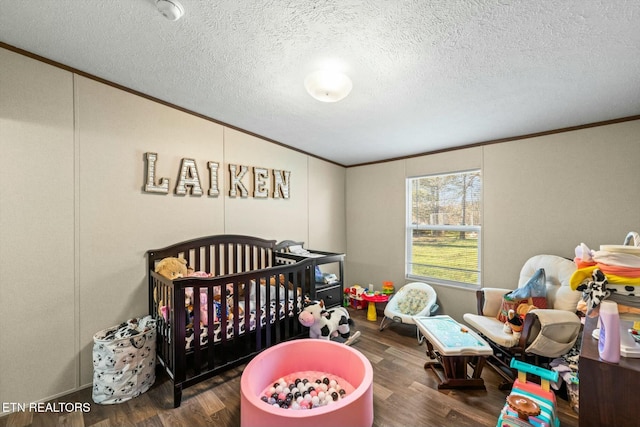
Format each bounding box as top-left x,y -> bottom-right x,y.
346,120 -> 640,320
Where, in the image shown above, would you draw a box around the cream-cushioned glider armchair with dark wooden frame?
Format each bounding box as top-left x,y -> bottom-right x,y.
463,255 -> 581,389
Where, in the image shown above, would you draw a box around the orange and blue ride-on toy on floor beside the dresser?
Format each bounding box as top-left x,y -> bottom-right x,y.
496,359 -> 560,427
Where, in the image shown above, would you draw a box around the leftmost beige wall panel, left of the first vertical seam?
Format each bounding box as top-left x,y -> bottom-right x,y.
0,49 -> 79,402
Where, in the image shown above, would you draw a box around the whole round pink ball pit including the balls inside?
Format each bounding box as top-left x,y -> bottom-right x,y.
240,339 -> 373,427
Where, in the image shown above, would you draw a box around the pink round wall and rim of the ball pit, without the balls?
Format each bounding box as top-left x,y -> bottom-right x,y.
240,339 -> 373,427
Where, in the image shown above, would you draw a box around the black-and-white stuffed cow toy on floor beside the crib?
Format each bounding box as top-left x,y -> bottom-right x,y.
298,300 -> 353,340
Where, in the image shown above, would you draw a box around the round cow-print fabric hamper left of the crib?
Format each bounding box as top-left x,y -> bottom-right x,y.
92,316 -> 156,404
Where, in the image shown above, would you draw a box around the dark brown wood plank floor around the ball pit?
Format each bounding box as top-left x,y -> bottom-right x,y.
0,310 -> 578,427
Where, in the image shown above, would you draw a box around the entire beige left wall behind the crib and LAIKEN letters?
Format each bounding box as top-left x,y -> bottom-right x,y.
0,49 -> 346,402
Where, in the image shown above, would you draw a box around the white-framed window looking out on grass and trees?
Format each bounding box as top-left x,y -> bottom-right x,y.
406,170 -> 482,287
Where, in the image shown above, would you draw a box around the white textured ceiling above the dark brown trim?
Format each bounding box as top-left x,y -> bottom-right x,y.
0,0 -> 640,165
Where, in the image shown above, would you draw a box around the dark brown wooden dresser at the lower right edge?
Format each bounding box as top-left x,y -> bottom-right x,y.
579,318 -> 640,427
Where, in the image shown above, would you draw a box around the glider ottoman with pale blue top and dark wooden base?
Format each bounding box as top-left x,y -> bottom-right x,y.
415,315 -> 493,389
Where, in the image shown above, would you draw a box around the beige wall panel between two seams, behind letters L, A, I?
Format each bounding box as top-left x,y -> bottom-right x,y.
74,76 -> 230,385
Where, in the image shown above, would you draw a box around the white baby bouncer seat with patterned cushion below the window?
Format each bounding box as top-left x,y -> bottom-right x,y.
380,282 -> 438,344
